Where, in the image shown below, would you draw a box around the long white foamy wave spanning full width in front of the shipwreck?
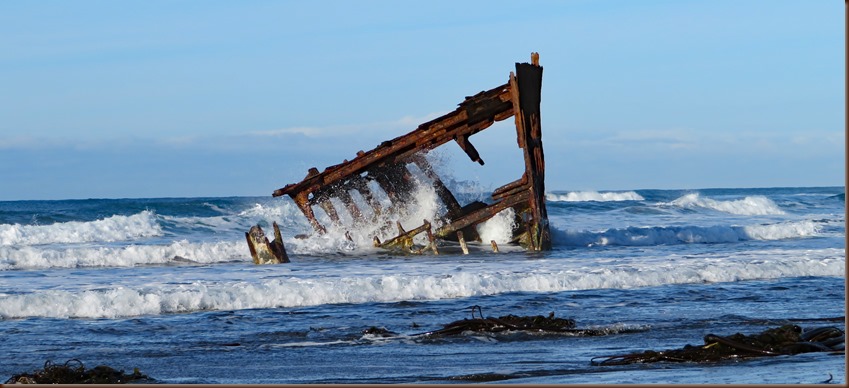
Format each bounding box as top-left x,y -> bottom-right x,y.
0,249 -> 845,319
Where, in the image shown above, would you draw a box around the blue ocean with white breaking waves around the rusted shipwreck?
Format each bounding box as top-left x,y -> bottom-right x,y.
0,187 -> 846,384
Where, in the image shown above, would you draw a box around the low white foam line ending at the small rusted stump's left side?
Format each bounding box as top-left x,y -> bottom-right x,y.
0,240 -> 250,271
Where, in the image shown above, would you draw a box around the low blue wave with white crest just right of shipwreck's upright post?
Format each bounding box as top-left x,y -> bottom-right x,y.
552,221 -> 821,246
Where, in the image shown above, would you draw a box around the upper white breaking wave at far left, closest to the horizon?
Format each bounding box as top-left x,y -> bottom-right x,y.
0,210 -> 162,246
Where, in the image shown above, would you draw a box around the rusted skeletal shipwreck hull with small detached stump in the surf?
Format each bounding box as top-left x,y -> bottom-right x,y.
245,53 -> 551,264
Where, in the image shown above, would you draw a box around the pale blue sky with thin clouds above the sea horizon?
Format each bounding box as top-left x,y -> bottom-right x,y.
0,0 -> 845,200
